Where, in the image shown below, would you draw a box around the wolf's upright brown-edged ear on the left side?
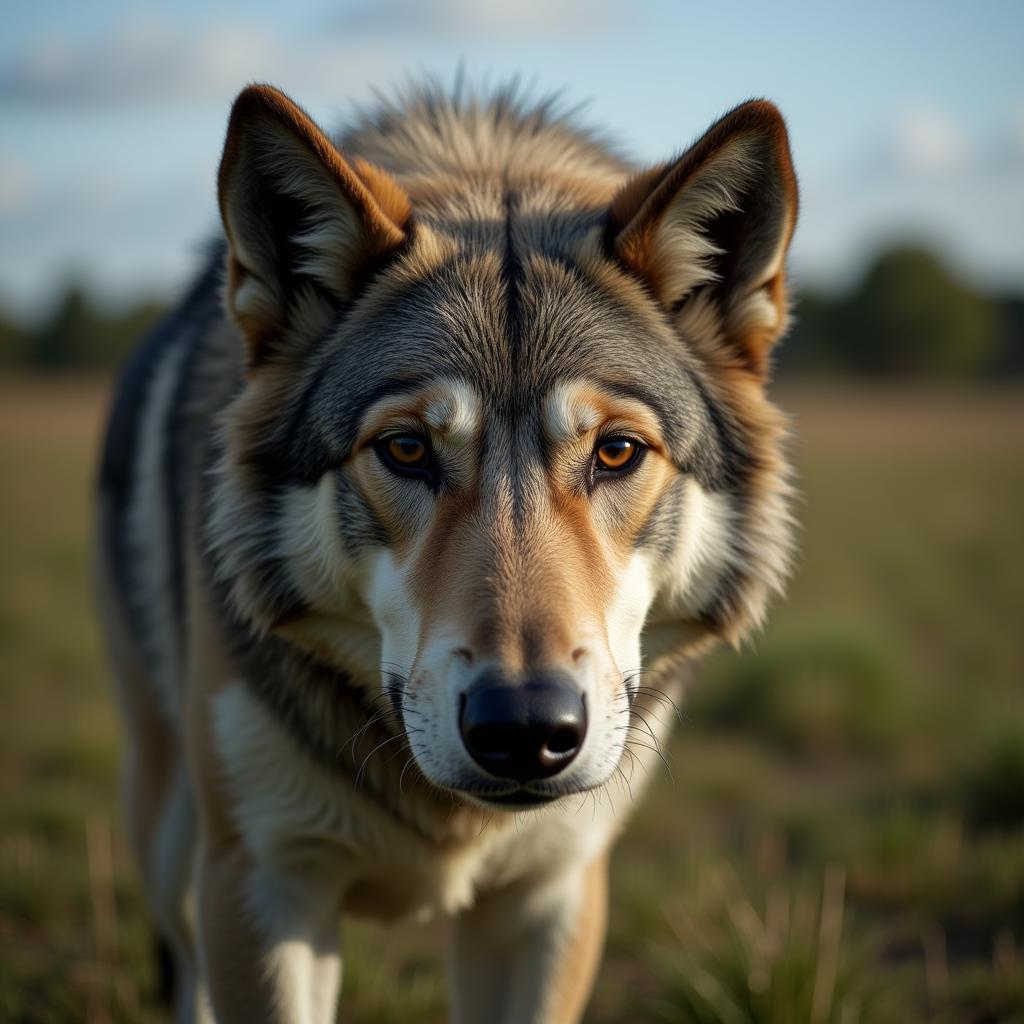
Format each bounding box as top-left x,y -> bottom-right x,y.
218,85 -> 410,364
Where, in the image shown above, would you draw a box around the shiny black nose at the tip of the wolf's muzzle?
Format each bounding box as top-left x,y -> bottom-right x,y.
459,675 -> 587,782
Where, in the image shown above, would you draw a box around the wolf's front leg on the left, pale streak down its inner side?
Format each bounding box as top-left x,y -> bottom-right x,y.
197,845 -> 341,1024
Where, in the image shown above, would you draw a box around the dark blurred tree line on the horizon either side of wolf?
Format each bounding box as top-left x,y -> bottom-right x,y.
0,246 -> 1024,378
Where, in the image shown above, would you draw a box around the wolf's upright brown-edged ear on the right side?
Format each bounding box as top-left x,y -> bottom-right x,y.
610,100 -> 797,376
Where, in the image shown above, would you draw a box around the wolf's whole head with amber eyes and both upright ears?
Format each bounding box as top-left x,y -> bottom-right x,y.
209,88 -> 795,807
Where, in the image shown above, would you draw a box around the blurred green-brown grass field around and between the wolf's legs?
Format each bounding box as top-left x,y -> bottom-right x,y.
0,378 -> 1024,1024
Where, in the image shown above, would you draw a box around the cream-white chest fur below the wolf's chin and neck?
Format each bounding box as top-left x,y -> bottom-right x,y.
211,682 -> 627,919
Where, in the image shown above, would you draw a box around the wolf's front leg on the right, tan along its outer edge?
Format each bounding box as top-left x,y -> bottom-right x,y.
452,855 -> 608,1024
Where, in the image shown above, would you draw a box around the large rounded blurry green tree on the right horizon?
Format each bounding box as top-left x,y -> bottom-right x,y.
831,247 -> 1002,376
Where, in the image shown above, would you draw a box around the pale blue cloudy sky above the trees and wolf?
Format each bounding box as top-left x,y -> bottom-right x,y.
0,0 -> 1024,313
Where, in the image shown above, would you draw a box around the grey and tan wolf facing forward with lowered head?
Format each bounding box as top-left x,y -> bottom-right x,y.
97,85 -> 797,1024
